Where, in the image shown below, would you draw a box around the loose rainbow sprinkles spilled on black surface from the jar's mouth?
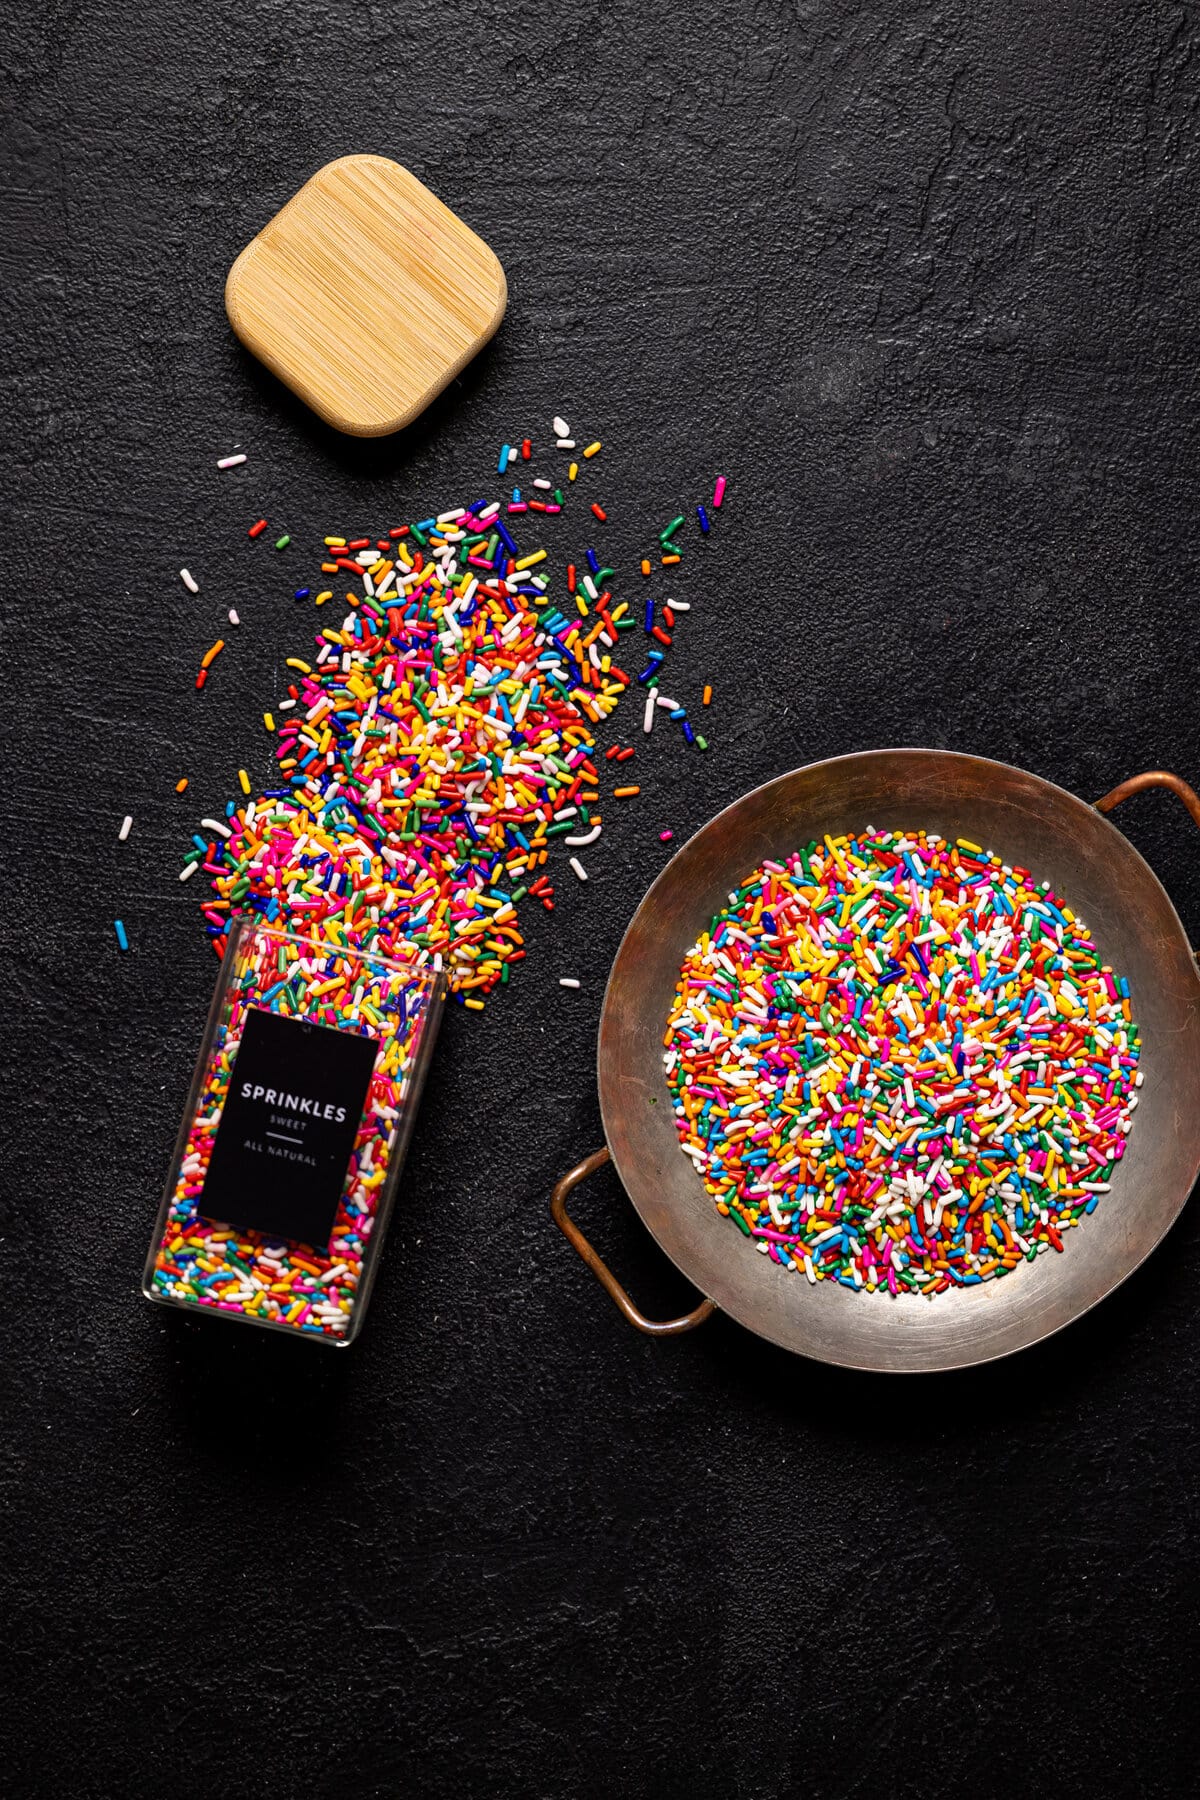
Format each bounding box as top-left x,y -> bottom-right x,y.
192,439 -> 726,1010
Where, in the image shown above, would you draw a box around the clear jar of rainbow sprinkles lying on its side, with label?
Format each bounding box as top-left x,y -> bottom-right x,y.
142,918 -> 444,1345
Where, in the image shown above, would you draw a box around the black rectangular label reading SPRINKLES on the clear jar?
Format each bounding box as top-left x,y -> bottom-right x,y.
200,1010 -> 380,1249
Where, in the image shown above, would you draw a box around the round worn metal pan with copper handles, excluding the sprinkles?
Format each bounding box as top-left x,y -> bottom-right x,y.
552,751 -> 1200,1372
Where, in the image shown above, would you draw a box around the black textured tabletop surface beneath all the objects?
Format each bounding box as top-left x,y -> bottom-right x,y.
0,0 -> 1200,1800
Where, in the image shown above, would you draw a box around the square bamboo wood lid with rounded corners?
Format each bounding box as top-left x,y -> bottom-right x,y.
225,157 -> 507,437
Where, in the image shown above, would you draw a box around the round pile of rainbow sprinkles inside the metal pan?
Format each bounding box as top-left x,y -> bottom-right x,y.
664,830 -> 1142,1294
